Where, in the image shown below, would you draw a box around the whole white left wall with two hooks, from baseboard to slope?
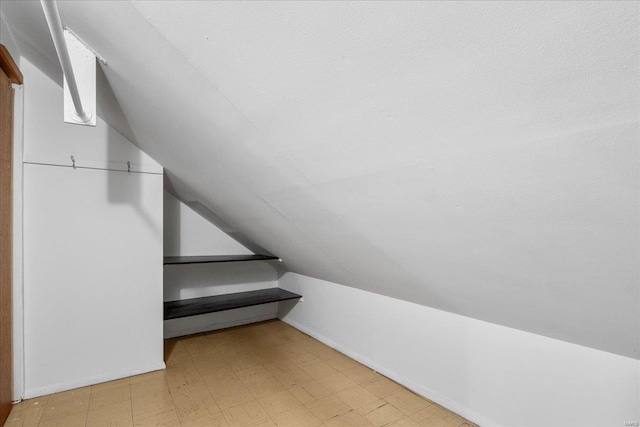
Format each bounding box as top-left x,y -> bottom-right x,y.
20,54 -> 164,398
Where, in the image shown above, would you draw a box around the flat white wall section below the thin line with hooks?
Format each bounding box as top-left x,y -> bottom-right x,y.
24,164 -> 164,397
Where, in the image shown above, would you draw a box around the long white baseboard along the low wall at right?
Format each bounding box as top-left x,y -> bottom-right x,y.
280,319 -> 502,427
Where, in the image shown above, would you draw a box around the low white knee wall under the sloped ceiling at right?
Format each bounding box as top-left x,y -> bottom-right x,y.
279,273 -> 640,427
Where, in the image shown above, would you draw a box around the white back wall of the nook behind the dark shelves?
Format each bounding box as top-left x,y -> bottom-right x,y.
164,191 -> 278,338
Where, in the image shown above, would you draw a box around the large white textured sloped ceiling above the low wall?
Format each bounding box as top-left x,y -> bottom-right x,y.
1,1 -> 640,358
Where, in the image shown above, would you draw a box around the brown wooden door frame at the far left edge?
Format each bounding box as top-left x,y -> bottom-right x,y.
0,44 -> 23,424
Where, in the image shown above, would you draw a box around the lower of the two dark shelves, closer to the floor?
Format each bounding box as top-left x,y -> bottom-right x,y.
164,288 -> 302,320
